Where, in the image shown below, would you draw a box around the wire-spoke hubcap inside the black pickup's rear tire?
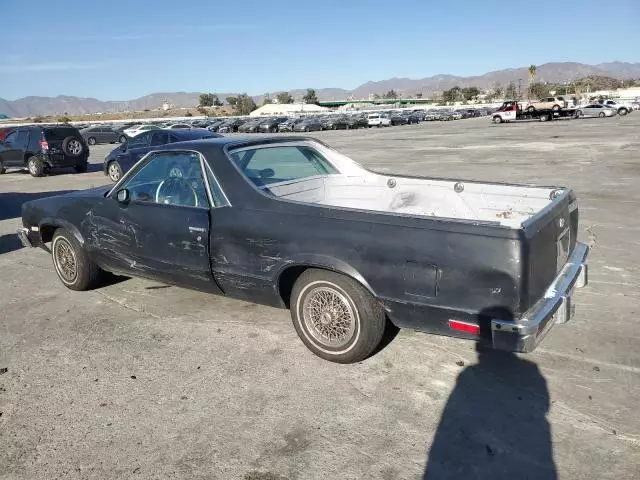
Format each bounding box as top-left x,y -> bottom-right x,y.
302,286 -> 356,348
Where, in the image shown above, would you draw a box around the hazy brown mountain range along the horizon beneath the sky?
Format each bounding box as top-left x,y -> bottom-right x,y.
0,62 -> 640,117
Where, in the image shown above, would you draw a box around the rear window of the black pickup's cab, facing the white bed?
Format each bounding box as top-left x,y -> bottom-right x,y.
231,146 -> 340,187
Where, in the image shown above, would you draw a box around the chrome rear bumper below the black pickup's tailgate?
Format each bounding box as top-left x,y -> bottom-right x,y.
491,243 -> 589,352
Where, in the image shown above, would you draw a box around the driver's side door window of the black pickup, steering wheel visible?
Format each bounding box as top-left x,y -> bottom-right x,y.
121,152 -> 209,208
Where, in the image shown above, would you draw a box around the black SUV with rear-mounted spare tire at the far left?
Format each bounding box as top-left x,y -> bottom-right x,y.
0,125 -> 89,177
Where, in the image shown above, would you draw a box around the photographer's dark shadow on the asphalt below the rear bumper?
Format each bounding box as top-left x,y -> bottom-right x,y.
423,344 -> 557,480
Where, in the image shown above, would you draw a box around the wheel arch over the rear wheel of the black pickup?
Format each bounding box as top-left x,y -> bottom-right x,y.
275,255 -> 378,308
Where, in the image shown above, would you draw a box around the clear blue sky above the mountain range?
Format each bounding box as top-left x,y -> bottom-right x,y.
0,0 -> 640,100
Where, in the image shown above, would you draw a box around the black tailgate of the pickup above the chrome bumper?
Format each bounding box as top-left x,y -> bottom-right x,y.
520,188 -> 578,312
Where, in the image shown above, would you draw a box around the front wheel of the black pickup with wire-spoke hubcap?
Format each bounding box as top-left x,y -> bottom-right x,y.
51,228 -> 102,290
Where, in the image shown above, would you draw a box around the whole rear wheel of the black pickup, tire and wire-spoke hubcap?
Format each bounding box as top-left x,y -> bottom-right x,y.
290,268 -> 386,363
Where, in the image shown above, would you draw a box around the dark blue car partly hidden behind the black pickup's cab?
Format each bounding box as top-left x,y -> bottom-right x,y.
103,128 -> 220,182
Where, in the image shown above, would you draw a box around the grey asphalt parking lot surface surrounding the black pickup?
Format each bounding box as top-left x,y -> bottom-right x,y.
0,117 -> 640,480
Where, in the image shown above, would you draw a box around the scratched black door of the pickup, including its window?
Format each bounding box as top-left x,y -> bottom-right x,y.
88,151 -> 221,293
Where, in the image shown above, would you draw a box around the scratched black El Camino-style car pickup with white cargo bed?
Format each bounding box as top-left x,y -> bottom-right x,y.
18,136 -> 589,363
